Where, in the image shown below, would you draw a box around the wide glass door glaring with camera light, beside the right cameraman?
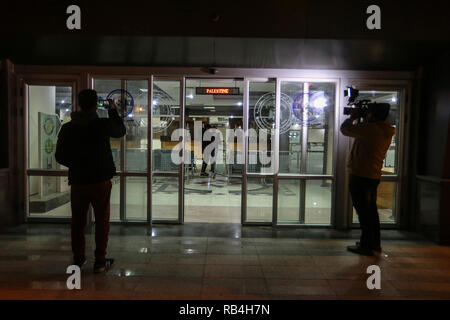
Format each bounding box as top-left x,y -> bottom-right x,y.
274,79 -> 338,225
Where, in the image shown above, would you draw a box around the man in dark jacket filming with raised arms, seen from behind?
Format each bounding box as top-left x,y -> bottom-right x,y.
55,89 -> 126,273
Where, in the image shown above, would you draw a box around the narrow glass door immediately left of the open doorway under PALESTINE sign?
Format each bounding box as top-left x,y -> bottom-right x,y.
150,78 -> 184,223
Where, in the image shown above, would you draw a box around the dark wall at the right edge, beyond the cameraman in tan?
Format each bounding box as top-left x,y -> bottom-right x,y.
416,50 -> 450,244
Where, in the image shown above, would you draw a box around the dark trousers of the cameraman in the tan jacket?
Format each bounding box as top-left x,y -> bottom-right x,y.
349,174 -> 381,249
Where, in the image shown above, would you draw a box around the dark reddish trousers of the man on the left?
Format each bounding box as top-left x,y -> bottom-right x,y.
70,180 -> 112,263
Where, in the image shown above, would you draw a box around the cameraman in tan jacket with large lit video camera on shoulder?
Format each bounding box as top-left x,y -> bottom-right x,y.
341,90 -> 395,256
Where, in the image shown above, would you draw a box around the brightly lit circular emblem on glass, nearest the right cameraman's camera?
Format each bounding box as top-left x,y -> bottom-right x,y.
292,91 -> 327,125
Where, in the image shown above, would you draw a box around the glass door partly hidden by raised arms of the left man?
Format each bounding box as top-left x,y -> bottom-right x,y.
92,77 -> 149,222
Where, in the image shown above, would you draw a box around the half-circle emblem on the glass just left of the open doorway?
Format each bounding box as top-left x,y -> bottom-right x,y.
152,90 -> 178,132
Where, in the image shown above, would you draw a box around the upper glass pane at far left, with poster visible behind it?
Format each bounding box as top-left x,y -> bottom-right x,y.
28,85 -> 72,170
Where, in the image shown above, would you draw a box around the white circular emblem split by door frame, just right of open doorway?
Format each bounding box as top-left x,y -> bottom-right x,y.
253,92 -> 292,133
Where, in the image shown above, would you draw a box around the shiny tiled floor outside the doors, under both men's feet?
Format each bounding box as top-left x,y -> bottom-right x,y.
0,224 -> 450,299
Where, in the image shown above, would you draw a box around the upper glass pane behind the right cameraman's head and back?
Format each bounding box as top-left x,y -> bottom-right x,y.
358,90 -> 400,175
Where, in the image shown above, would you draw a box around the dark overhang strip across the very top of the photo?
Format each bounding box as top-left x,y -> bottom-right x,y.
0,0 -> 450,40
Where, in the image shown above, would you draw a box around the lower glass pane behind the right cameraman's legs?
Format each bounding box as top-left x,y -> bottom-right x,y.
353,181 -> 397,223
